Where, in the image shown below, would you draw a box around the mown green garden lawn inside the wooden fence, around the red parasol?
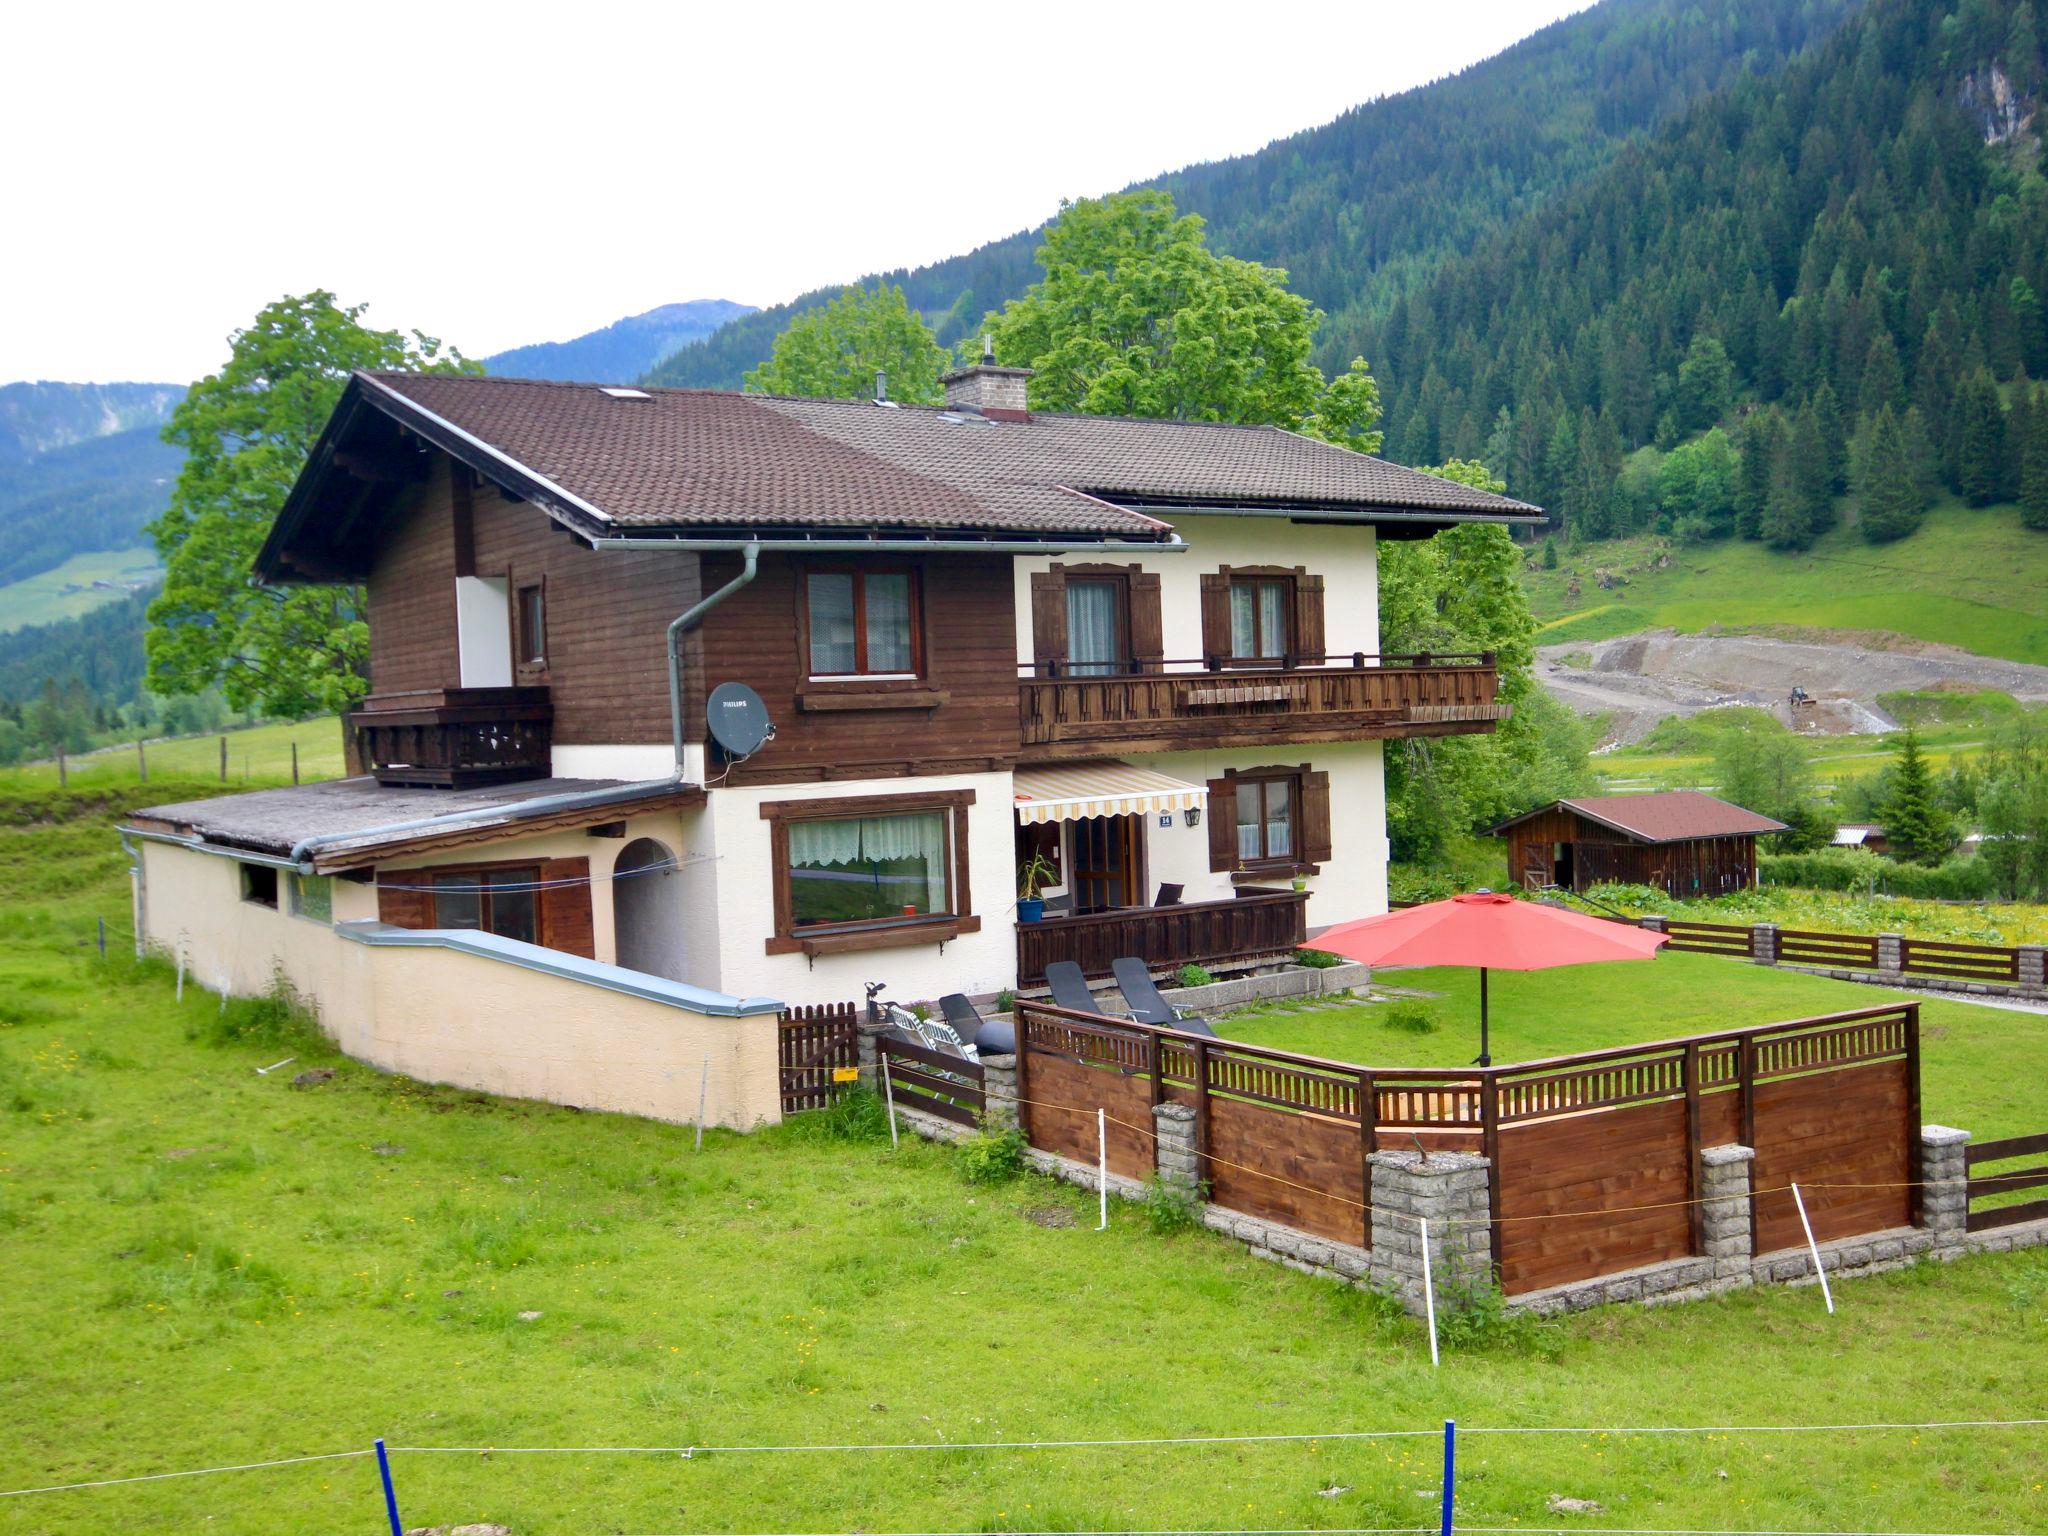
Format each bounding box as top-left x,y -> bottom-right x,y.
1217,954 -> 2048,1139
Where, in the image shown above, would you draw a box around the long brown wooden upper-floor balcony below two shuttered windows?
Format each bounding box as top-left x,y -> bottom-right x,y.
1018,651 -> 1509,758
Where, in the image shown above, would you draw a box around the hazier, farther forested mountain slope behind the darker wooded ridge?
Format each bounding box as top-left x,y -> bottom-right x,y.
647,0 -> 1853,389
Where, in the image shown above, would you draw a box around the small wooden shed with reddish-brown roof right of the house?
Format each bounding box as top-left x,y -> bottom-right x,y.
1493,788 -> 1786,897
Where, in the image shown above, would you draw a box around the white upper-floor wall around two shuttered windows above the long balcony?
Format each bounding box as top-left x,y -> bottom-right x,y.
1016,514 -> 1380,662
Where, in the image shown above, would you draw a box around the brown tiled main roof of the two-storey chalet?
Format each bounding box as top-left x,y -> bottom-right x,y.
367,373 -> 1536,539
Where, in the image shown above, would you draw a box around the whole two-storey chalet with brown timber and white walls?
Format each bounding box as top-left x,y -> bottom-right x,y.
127,358 -> 1540,1122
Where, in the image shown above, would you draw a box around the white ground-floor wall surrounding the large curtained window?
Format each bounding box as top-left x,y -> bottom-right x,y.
690,772 -> 1016,1004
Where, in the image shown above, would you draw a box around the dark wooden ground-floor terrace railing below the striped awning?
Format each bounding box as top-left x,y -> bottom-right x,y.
1018,891 -> 1309,987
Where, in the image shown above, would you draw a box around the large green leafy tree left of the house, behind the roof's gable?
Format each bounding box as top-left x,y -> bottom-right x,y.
145,291 -> 481,715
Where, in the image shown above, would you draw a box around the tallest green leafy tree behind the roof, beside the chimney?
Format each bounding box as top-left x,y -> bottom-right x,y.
987,188 -> 1335,440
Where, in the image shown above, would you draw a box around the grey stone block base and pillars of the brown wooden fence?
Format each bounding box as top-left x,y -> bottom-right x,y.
880,1081 -> 2048,1317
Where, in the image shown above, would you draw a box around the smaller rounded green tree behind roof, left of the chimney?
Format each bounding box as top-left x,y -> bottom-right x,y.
748,283 -> 948,406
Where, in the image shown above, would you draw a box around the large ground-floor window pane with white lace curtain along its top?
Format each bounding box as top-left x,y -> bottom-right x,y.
788,811 -> 952,928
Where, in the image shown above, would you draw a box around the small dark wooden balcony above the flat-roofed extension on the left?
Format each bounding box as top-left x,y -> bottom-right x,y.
348,688 -> 555,788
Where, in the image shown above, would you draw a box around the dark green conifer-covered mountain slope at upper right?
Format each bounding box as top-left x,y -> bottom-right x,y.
1364,0 -> 2048,528
